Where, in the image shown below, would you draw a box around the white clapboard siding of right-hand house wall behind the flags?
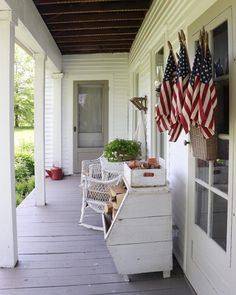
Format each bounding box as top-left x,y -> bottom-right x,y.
129,0 -> 216,267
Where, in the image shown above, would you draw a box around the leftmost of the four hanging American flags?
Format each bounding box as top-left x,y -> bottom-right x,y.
156,50 -> 177,132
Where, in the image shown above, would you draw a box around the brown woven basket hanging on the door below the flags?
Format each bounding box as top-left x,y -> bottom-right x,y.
190,126 -> 217,161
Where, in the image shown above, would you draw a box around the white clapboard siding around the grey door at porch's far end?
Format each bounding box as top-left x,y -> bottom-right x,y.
62,54 -> 129,174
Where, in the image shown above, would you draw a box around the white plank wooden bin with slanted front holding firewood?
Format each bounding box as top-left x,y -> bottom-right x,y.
103,184 -> 172,278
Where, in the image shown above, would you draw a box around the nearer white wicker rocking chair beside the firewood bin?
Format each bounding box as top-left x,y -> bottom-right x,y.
79,170 -> 122,230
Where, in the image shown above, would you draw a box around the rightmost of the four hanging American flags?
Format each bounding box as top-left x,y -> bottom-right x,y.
198,47 -> 217,139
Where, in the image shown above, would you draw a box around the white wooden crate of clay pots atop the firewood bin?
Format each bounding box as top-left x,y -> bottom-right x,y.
124,163 -> 166,187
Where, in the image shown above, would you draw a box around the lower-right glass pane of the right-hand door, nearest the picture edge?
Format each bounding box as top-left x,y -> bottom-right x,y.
211,193 -> 228,250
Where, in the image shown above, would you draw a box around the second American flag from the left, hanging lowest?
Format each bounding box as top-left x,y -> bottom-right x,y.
169,44 -> 190,142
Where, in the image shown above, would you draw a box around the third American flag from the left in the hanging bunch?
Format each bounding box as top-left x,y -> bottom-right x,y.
180,44 -> 202,133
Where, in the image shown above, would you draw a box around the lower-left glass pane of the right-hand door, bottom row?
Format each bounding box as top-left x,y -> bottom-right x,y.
195,183 -> 208,232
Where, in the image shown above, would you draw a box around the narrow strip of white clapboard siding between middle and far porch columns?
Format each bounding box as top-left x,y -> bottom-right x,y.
45,72 -> 53,168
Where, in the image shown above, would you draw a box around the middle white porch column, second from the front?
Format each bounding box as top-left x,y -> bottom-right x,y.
34,53 -> 46,206
